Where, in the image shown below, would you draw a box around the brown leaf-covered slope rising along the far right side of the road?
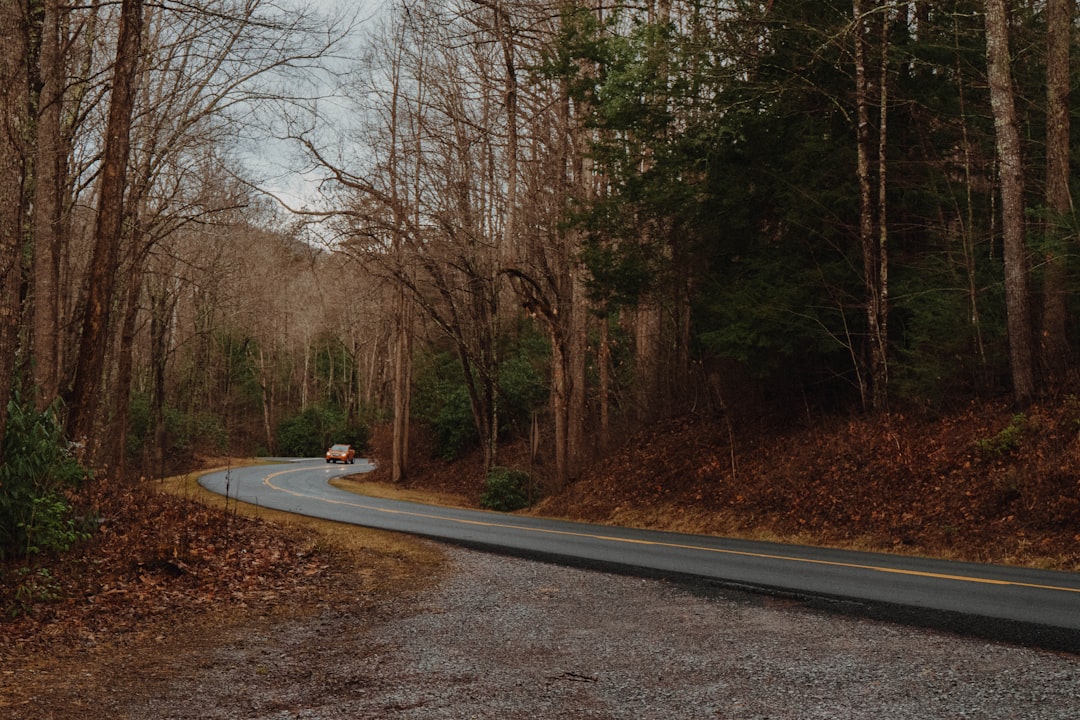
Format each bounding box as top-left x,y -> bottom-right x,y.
376,398 -> 1080,570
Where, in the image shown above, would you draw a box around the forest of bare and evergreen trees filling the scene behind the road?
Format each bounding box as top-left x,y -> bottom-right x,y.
0,0 -> 1080,557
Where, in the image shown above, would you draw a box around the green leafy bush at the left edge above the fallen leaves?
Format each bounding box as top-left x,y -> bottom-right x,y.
0,395 -> 89,559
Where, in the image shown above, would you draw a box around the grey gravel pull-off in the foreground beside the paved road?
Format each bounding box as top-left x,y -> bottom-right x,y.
98,548 -> 1080,720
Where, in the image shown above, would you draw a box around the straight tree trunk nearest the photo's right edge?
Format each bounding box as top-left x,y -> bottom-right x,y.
1040,0 -> 1075,386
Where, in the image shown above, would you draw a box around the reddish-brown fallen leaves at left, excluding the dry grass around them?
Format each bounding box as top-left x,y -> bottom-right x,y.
0,484 -> 337,647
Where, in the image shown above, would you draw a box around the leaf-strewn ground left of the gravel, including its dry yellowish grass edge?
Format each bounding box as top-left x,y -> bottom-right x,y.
0,480 -> 443,720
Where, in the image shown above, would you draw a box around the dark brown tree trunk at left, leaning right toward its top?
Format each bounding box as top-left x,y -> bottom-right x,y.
68,0 -> 144,451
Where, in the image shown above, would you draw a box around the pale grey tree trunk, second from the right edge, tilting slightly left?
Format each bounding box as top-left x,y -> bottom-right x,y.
986,0 -> 1035,407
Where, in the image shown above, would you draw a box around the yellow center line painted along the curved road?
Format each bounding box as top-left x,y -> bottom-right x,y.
262,468 -> 1080,594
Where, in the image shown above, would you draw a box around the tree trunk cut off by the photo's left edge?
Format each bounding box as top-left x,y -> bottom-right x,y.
0,1 -> 28,451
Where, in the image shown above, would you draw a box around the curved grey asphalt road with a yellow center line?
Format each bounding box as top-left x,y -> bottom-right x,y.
200,459 -> 1080,653
